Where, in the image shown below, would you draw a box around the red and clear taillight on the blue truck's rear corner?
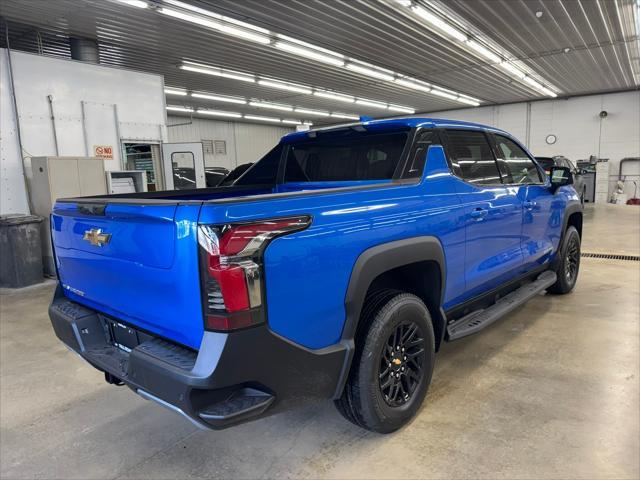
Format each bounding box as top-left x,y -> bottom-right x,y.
198,217 -> 310,331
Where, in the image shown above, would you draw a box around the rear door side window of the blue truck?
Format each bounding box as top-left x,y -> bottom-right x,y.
447,130 -> 501,185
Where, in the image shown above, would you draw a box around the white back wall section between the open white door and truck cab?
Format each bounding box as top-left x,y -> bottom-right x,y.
167,116 -> 293,170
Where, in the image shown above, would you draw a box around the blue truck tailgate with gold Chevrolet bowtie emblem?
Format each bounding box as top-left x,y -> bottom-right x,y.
51,202 -> 204,348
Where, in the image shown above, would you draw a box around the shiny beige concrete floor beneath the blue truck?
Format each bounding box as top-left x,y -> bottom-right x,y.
0,205 -> 640,479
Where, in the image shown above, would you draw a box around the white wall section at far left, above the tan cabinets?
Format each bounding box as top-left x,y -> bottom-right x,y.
0,49 -> 166,214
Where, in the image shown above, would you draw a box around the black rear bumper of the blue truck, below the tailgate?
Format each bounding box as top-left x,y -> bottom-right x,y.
49,287 -> 347,429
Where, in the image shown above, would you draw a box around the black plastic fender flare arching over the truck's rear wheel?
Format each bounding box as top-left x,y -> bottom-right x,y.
334,236 -> 446,398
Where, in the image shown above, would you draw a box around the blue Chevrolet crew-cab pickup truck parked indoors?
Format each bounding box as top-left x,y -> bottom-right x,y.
49,118 -> 582,433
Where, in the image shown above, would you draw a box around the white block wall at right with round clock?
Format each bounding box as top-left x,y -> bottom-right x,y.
429,91 -> 640,196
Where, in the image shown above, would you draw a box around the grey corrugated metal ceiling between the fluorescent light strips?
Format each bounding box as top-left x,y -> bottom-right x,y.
0,0 -> 640,123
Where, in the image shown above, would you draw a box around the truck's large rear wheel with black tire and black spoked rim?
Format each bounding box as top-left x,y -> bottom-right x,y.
335,290 -> 435,433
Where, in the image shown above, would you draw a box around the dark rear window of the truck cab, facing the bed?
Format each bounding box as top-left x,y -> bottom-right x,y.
284,131 -> 408,183
